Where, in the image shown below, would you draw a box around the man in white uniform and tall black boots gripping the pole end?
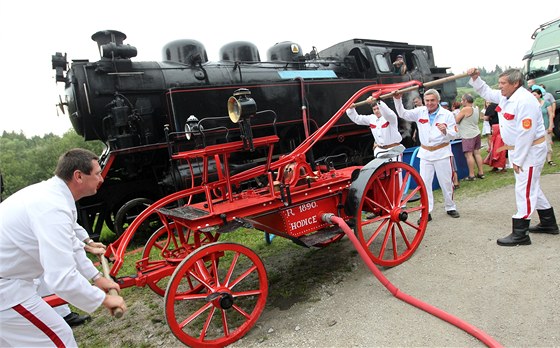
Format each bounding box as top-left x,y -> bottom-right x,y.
467,68 -> 558,246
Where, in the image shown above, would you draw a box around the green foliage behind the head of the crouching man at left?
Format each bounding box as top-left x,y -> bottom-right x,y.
0,130 -> 104,198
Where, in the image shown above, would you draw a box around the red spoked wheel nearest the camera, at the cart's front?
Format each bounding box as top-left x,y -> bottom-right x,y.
165,242 -> 268,347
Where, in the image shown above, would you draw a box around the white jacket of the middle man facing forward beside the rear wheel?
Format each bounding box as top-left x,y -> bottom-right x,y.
393,98 -> 459,161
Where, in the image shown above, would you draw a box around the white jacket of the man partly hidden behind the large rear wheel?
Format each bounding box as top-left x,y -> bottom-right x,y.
346,102 -> 402,146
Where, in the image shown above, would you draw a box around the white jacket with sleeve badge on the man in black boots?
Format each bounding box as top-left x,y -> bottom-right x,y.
469,78 -> 546,167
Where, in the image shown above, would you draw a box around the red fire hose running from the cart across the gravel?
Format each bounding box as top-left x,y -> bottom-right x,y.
322,214 -> 502,347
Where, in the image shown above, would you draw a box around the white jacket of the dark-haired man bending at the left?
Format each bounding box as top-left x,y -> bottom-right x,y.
0,176 -> 105,313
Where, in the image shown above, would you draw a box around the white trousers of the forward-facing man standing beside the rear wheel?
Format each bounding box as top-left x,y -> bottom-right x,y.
420,156 -> 457,213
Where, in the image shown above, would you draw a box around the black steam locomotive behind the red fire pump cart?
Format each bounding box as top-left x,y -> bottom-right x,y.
52,30 -> 457,238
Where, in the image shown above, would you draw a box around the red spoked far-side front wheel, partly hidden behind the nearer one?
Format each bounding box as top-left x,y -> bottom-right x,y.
141,222 -> 219,296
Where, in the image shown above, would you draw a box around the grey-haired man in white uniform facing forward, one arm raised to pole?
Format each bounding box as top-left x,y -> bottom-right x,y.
393,89 -> 460,221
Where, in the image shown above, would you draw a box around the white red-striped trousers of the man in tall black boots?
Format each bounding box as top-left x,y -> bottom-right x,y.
513,164 -> 551,219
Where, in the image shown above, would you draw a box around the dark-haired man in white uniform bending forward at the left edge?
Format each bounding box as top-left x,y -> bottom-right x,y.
0,149 -> 126,347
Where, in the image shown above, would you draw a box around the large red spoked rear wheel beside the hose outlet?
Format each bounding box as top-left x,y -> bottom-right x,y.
355,162 -> 428,267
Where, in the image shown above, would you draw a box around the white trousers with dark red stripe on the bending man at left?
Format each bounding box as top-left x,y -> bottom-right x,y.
0,295 -> 78,347
